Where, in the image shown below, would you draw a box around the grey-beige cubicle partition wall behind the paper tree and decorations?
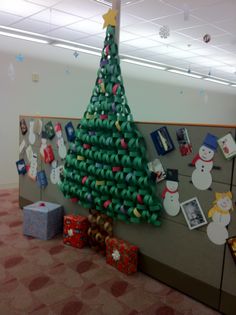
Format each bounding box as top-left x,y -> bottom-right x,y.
19,116 -> 236,315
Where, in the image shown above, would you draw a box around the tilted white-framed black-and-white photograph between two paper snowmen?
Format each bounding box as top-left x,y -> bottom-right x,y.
180,197 -> 207,230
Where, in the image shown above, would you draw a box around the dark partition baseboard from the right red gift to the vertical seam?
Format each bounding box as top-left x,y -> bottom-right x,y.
139,254 -> 220,315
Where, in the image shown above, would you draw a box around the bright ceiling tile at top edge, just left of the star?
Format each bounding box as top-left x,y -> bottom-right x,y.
54,0 -> 107,18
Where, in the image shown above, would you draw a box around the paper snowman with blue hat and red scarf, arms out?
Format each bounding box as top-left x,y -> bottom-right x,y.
192,133 -> 217,190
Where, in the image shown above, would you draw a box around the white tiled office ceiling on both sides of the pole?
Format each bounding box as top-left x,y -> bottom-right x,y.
0,0 -> 236,82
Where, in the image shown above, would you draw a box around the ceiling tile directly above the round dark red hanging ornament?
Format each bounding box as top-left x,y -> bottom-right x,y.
178,24 -> 226,39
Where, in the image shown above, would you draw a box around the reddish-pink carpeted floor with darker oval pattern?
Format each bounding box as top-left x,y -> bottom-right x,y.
0,189 -> 219,315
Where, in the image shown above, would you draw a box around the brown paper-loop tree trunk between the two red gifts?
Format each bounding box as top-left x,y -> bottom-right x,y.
88,211 -> 113,256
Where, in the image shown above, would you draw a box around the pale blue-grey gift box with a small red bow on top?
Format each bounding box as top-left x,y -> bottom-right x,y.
23,201 -> 63,240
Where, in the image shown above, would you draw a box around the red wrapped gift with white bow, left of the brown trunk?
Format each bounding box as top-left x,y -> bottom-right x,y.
63,214 -> 89,248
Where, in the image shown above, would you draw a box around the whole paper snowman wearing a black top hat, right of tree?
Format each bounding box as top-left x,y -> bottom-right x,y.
161,169 -> 180,216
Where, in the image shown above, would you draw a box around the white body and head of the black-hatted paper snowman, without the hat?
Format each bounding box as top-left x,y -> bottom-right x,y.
162,180 -> 180,216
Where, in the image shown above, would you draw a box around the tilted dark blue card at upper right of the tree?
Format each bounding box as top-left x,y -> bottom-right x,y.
151,127 -> 175,155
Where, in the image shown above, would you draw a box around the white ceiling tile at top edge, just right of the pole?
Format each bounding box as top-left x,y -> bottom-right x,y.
124,0 -> 180,20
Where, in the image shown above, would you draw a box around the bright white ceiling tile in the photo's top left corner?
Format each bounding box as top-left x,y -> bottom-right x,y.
0,0 -> 44,17
